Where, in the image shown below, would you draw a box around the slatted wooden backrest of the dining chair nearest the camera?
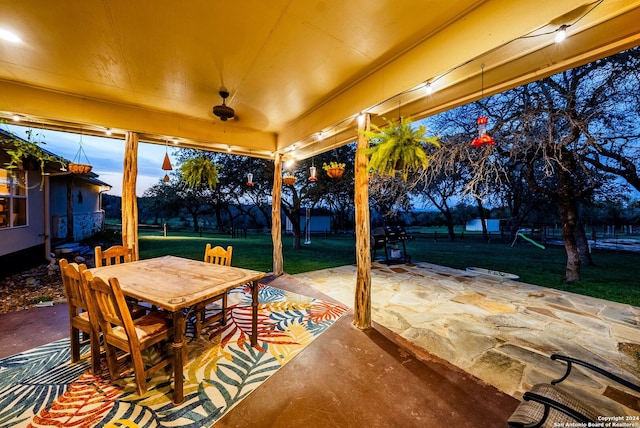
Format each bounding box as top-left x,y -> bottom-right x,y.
88,276 -> 139,346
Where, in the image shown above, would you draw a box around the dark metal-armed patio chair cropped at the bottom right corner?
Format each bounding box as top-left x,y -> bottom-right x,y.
508,354 -> 640,428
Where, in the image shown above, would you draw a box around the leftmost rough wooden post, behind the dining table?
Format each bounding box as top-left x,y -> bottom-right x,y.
122,131 -> 140,260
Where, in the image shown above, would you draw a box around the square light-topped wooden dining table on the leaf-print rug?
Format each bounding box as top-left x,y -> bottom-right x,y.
90,256 -> 266,404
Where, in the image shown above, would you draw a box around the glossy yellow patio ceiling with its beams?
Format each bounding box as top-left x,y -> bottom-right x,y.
0,0 -> 640,157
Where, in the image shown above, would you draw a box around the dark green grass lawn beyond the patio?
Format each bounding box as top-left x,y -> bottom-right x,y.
139,231 -> 640,306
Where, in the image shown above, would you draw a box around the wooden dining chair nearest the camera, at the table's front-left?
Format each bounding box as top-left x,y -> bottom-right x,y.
89,277 -> 173,395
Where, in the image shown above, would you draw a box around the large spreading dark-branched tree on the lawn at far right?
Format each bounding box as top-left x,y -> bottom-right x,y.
472,49 -> 638,283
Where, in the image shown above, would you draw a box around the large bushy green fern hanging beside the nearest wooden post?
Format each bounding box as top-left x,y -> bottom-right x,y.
363,117 -> 440,181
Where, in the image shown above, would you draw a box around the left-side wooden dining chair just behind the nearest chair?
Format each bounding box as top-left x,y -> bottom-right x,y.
59,259 -> 100,374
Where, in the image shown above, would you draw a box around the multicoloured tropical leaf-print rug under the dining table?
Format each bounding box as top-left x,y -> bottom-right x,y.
0,285 -> 347,428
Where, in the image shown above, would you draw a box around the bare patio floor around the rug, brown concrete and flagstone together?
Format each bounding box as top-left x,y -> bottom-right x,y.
0,263 -> 640,427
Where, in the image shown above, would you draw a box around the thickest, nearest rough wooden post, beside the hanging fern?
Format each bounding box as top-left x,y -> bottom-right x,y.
353,114 -> 371,330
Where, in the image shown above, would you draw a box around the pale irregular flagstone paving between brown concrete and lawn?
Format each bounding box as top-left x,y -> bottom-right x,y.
294,263 -> 640,415
